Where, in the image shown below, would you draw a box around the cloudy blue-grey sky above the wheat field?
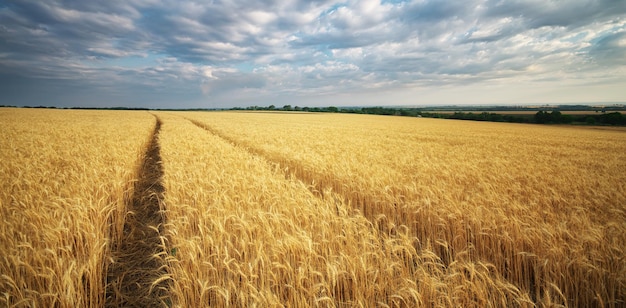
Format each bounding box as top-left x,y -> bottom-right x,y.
0,0 -> 626,108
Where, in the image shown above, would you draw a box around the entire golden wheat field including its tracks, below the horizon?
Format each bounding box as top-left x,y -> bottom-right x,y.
0,108 -> 626,307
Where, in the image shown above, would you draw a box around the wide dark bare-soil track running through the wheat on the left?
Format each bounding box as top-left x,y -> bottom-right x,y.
105,116 -> 171,307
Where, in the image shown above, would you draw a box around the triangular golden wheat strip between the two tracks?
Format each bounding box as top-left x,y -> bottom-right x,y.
159,114 -> 529,307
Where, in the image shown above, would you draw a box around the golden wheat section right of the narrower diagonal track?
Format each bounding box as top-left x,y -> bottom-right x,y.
184,112 -> 626,307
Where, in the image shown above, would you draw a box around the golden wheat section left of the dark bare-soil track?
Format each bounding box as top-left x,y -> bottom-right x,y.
0,109 -> 154,307
